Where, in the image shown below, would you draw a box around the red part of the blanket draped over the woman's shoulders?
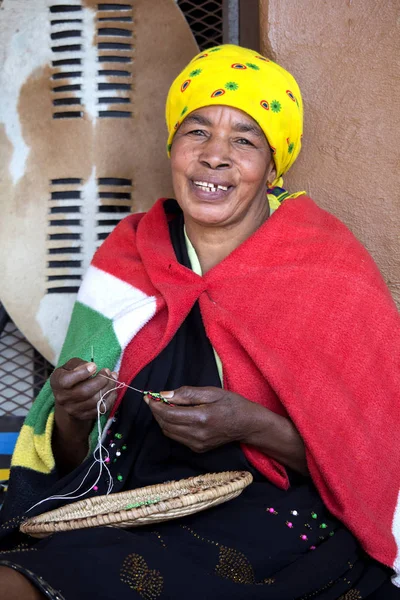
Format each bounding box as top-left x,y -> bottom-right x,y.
93,196 -> 400,571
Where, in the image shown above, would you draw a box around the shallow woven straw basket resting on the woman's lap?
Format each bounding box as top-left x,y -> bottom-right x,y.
20,471 -> 253,538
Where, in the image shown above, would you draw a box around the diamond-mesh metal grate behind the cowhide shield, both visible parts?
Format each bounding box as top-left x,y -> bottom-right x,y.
0,0 -> 226,417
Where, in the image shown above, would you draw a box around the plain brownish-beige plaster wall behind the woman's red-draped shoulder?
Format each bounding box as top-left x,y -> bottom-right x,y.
260,0 -> 400,306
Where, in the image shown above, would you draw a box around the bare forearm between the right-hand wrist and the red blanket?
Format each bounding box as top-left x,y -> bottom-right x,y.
240,402 -> 308,475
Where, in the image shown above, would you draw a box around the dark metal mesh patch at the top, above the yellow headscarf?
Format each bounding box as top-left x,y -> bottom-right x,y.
177,0 -> 223,50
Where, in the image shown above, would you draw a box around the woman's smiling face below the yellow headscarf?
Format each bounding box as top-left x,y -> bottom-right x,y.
171,106 -> 276,227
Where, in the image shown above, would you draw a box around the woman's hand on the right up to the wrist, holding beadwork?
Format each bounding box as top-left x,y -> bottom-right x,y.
145,386 -> 255,453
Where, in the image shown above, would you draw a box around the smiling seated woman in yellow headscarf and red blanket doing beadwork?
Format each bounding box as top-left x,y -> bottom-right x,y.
0,45 -> 400,600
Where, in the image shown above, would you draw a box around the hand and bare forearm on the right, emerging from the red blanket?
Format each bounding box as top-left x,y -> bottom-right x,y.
145,386 -> 308,475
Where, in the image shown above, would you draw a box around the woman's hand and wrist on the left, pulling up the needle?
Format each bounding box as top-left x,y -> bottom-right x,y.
50,358 -> 117,472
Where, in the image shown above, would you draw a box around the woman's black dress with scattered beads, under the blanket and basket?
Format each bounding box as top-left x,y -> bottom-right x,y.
0,211 -> 400,600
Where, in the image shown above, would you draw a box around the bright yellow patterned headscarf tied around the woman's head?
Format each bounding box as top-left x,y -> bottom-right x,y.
166,44 -> 304,208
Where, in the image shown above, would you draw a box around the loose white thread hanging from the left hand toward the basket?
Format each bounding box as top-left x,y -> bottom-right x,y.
26,382 -> 124,512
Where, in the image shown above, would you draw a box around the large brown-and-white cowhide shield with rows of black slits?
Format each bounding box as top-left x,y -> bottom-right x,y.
0,0 -> 197,363
